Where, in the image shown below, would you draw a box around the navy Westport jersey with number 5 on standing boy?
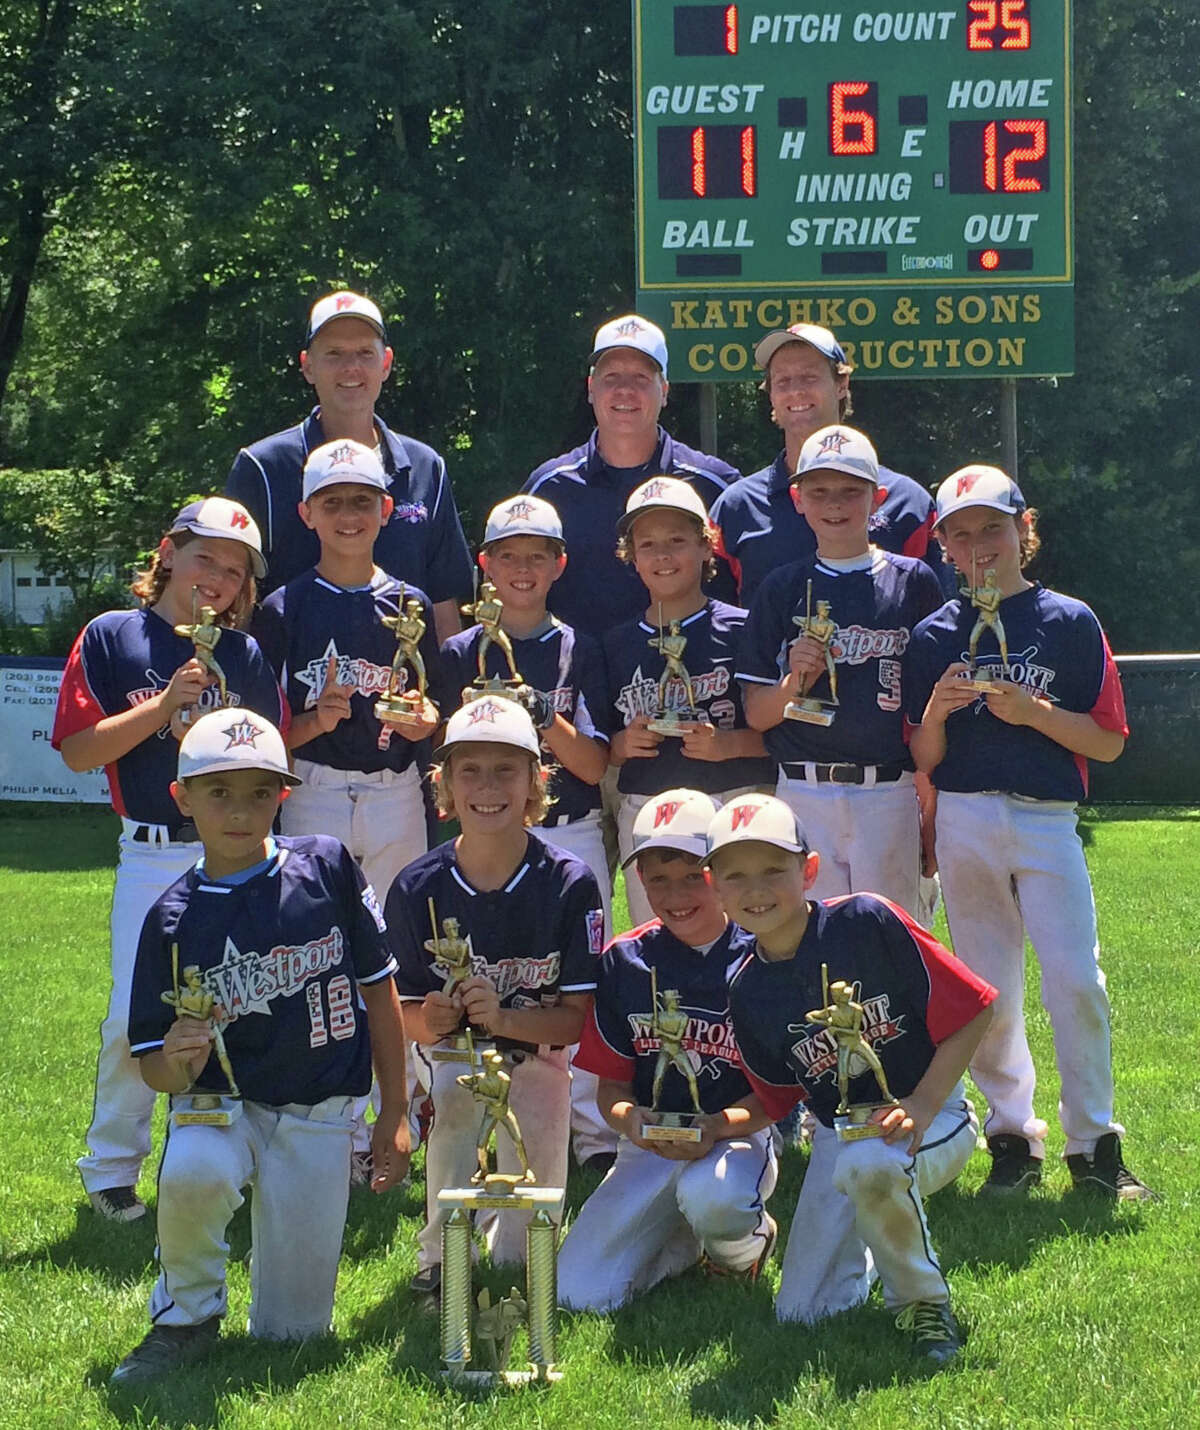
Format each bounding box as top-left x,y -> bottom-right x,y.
738,551 -> 941,765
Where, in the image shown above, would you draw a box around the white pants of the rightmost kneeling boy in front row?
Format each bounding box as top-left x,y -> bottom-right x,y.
775,1084 -> 978,1321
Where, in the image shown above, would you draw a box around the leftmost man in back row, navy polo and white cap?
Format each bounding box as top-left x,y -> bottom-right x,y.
225,292 -> 472,641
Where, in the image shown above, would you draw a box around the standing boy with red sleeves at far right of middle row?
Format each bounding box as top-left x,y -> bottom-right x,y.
905,466 -> 1153,1201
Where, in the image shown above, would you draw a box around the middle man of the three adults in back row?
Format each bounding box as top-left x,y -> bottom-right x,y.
522,313 -> 741,636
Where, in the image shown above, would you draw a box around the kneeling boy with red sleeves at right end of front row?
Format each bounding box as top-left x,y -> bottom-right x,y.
708,795 -> 995,1366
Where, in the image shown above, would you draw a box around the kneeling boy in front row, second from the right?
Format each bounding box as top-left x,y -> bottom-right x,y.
558,789 -> 777,1311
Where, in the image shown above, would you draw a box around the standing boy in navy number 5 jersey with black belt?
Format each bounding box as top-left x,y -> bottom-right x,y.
738,425 -> 943,914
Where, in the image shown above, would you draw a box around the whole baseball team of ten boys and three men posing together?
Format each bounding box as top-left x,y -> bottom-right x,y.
53,292 -> 1153,1387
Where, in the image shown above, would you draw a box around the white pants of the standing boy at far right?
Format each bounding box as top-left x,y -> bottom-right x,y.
937,792 -> 1124,1157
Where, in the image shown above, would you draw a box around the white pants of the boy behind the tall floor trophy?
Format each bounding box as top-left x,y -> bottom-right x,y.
416,1045 -> 571,1271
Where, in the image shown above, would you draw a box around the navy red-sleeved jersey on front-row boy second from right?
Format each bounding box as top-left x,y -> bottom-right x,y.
575,919 -> 754,1113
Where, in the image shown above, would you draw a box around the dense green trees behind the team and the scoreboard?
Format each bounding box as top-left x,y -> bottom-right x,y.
0,0 -> 1200,648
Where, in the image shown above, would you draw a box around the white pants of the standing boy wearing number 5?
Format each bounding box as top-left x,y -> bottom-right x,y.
775,771 -> 921,918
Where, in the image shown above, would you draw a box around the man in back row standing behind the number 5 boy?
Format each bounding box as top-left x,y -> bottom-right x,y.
709,323 -> 953,606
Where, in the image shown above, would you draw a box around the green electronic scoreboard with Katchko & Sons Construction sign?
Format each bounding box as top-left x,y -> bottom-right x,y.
634,0 -> 1074,382
